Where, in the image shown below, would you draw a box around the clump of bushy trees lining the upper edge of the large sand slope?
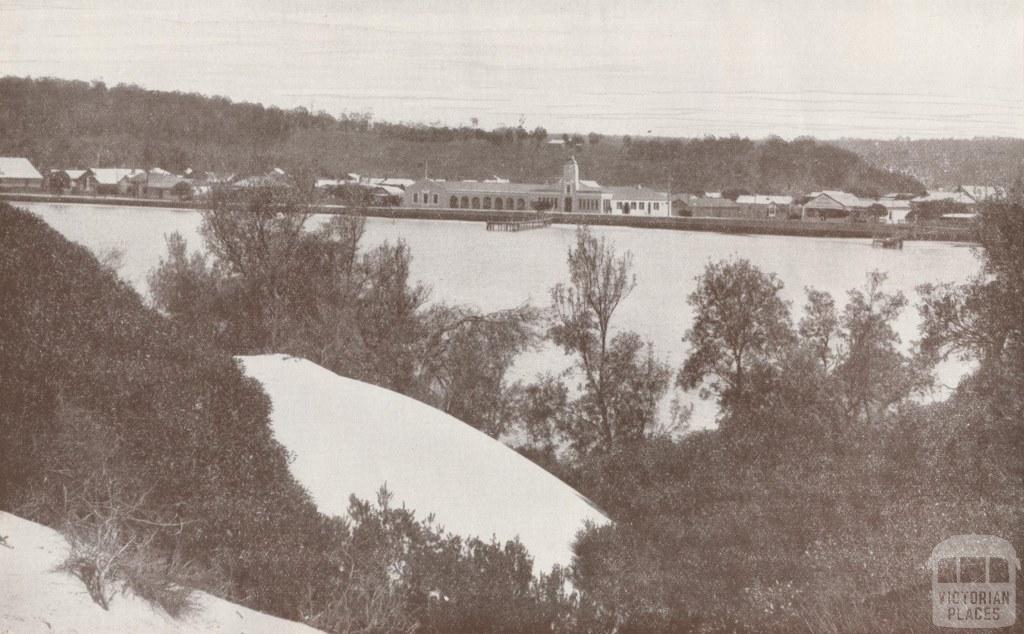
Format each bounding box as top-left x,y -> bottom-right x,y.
150,187 -> 539,421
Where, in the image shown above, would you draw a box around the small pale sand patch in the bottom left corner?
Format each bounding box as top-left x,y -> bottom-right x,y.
0,511 -> 316,634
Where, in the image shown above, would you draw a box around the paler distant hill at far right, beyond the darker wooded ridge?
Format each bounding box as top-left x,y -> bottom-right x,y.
828,138 -> 1024,188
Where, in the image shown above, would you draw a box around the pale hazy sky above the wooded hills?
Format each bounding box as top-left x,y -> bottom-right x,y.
0,0 -> 1024,138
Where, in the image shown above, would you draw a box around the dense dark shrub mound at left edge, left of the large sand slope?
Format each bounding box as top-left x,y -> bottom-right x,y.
0,206 -> 342,616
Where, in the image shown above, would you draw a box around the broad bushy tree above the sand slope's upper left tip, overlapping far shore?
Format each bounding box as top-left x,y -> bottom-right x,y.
150,187 -> 362,353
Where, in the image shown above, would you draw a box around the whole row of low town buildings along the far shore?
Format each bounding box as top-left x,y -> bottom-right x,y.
0,157 -> 1006,224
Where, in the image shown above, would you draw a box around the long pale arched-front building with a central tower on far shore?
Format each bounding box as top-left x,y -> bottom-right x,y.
402,157 -> 670,216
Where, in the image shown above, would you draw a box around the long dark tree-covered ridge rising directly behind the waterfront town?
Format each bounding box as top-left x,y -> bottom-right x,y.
0,77 -> 923,194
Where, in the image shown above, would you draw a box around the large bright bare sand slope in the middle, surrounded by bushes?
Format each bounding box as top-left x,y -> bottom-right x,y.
239,354 -> 607,572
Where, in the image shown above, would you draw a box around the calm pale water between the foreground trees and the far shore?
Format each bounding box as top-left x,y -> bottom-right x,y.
25,204 -> 979,427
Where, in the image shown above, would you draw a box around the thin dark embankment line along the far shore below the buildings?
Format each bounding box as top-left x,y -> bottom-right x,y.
0,193 -> 975,243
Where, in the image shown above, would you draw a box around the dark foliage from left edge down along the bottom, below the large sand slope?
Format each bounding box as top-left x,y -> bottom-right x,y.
0,205 -> 565,632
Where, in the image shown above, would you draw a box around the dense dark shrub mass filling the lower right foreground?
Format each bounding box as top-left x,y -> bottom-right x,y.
567,200 -> 1024,632
